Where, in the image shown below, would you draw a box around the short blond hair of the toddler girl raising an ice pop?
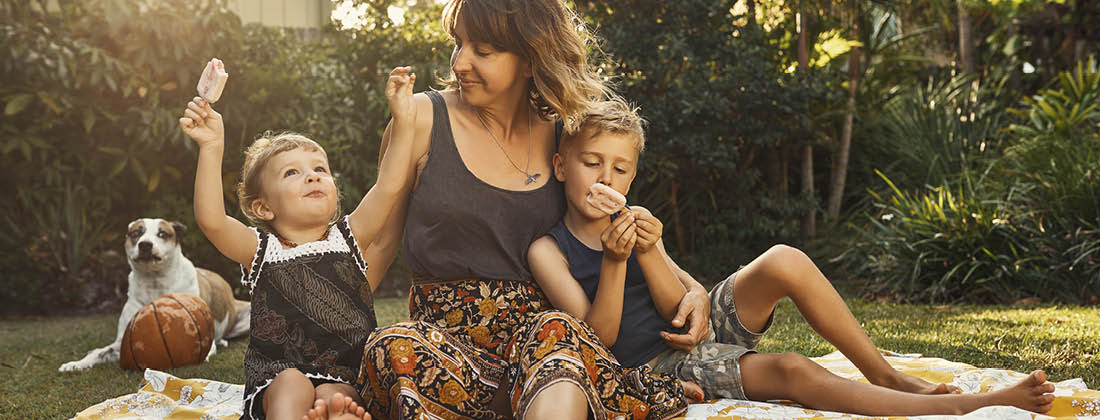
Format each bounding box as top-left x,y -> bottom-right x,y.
237,132 -> 341,233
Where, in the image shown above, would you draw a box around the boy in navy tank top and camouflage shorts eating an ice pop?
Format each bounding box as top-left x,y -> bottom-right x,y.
527,100 -> 1054,416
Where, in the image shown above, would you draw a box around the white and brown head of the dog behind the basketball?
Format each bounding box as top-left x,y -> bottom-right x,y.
125,219 -> 187,267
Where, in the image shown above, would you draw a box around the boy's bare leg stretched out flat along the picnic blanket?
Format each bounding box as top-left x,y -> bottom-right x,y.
740,353 -> 1054,416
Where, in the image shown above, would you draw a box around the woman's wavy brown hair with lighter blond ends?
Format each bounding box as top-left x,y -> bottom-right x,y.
443,0 -> 612,133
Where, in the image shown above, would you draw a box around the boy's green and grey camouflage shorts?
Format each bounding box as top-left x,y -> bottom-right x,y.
648,269 -> 774,399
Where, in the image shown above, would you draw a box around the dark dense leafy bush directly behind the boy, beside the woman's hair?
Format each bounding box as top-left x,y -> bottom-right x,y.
576,0 -> 829,280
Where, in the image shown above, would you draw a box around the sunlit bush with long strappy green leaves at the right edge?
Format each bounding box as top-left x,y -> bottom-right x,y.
846,59 -> 1100,303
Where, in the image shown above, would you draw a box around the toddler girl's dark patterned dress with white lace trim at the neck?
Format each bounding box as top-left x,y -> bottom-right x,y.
241,217 -> 377,419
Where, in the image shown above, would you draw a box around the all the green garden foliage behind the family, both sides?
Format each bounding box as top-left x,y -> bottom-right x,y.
0,0 -> 1100,314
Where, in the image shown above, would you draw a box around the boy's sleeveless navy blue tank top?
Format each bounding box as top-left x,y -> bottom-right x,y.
550,221 -> 682,367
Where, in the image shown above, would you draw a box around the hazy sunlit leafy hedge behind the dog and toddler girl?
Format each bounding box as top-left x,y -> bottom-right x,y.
0,0 -> 446,314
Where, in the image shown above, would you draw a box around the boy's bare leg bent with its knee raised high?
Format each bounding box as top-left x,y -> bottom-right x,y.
733,245 -> 958,394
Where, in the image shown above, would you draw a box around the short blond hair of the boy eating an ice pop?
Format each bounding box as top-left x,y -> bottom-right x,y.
558,97 -> 646,155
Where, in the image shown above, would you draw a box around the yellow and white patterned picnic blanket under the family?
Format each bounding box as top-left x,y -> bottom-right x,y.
74,352 -> 1100,420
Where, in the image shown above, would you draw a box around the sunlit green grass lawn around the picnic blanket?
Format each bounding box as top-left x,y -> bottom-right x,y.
0,298 -> 1100,419
